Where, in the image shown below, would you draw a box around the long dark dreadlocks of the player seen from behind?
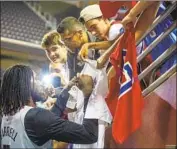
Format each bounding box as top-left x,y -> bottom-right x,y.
0,65 -> 34,115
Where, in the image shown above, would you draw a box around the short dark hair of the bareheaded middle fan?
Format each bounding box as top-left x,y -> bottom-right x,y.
57,17 -> 85,33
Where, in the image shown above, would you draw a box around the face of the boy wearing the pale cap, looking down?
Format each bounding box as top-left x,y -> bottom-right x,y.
85,18 -> 109,39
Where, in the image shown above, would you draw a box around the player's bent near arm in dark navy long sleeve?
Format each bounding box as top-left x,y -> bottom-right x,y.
24,108 -> 98,146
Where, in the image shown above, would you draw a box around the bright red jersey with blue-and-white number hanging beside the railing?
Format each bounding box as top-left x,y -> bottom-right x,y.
110,23 -> 143,144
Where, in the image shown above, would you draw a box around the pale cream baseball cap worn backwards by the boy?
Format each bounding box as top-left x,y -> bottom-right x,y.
79,4 -> 103,22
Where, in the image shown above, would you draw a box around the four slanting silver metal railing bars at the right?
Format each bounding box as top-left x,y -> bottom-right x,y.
136,2 -> 177,96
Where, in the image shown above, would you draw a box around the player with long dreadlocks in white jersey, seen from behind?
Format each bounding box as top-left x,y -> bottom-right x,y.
0,65 -> 98,148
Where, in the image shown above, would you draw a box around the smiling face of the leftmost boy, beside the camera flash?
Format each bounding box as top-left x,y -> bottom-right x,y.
46,45 -> 67,63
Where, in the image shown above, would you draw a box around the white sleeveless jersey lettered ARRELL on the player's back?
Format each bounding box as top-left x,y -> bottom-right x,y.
1,106 -> 52,149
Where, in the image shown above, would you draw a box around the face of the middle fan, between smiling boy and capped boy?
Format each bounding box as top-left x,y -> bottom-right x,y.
61,30 -> 88,50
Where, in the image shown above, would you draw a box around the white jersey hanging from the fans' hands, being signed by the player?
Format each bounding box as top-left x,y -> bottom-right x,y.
68,60 -> 112,148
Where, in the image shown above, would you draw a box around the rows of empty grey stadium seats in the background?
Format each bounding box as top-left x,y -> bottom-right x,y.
1,1 -> 47,44
